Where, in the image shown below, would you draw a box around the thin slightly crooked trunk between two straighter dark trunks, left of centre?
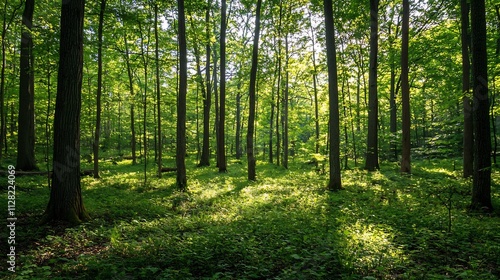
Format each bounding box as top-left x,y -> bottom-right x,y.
198,0 -> 212,166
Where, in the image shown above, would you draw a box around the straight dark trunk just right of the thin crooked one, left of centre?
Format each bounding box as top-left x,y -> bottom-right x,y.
217,0 -> 227,172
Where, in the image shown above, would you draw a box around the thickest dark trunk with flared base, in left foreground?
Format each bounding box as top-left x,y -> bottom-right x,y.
42,0 -> 89,224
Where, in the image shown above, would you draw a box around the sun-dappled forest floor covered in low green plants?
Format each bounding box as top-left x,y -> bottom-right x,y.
0,158 -> 500,280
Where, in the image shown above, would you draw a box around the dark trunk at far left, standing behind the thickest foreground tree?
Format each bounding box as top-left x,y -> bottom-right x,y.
16,0 -> 38,171
